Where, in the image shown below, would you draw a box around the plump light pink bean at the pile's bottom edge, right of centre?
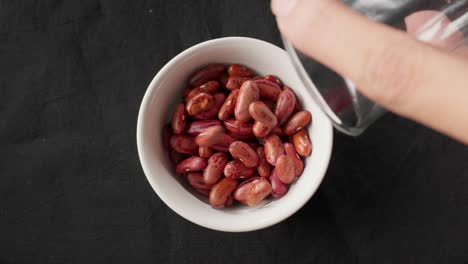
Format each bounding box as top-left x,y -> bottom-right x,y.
234,177 -> 271,206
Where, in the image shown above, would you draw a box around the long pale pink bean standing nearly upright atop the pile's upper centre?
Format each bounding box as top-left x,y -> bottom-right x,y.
234,81 -> 259,123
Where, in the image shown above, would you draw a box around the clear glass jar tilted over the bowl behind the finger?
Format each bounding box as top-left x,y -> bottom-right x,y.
283,0 -> 468,136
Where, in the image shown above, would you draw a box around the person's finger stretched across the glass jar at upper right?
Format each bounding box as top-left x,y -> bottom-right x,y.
272,0 -> 468,143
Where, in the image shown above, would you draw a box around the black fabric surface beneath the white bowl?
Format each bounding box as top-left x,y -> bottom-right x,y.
0,0 -> 468,264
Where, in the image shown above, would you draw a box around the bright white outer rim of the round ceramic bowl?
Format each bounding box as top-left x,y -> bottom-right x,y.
136,37 -> 333,232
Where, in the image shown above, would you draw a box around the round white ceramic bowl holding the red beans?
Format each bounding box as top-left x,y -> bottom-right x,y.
137,37 -> 333,232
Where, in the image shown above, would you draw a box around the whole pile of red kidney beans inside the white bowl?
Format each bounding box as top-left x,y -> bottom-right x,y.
164,64 -> 312,208
